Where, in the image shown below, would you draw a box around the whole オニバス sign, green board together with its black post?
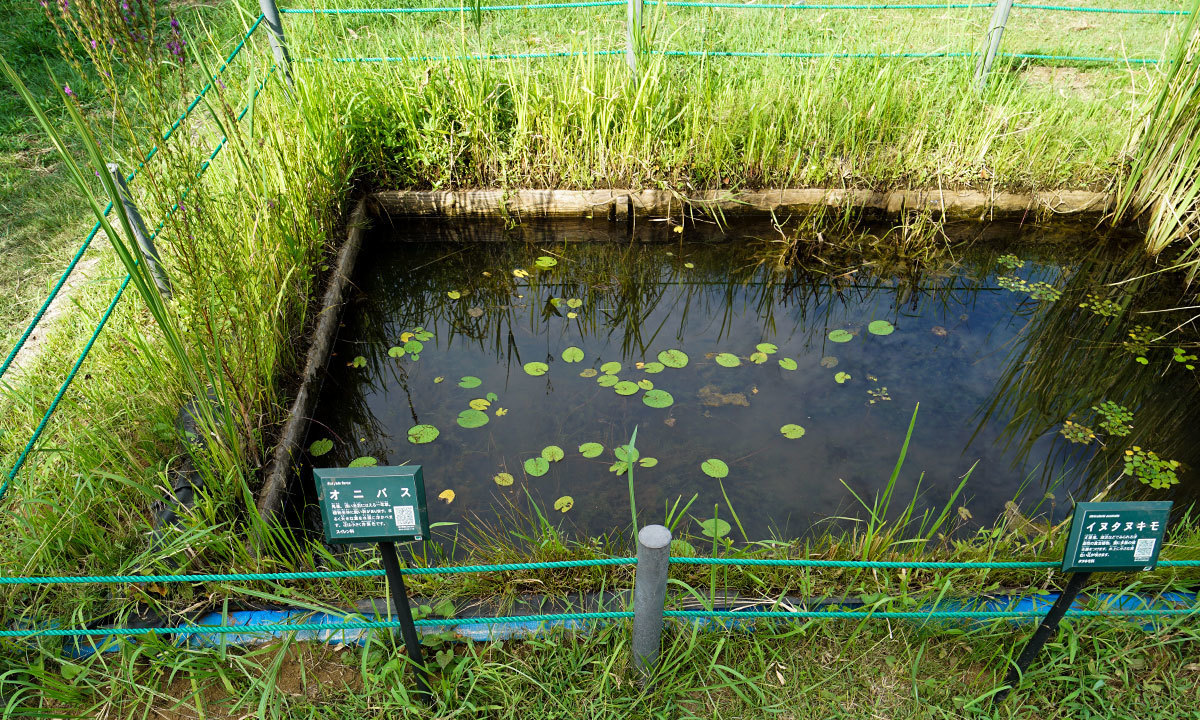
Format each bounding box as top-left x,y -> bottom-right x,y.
312,466 -> 432,698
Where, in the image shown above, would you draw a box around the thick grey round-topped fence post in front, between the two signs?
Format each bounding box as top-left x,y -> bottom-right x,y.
634,526 -> 671,677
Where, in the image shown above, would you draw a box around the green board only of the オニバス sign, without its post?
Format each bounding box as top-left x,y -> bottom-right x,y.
312,466 -> 430,542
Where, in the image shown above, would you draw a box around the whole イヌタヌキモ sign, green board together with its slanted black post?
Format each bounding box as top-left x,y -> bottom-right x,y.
996,502 -> 1171,702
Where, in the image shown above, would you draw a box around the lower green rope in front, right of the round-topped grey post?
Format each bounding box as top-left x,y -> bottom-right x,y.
662,604 -> 1200,620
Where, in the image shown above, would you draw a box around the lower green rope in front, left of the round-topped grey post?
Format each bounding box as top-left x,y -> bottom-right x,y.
0,611 -> 634,637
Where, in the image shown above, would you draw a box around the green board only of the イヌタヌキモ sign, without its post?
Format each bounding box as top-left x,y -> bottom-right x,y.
1062,500 -> 1171,572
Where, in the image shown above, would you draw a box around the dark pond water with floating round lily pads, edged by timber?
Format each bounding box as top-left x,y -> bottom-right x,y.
305,216 -> 1200,540
